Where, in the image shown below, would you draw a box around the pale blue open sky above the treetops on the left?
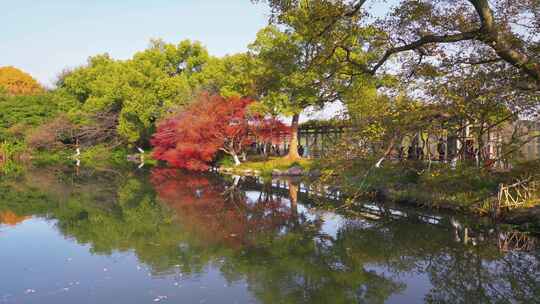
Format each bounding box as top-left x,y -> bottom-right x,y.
0,0 -> 268,85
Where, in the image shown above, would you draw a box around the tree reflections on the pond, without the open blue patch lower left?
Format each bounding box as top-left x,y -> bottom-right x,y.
0,169 -> 540,303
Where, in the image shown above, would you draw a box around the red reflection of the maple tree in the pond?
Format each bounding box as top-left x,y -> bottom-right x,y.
151,168 -> 295,249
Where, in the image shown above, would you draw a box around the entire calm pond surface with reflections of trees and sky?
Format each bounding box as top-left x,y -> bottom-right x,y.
0,169 -> 540,304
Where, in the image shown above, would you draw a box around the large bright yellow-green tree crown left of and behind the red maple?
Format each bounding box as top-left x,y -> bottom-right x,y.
58,40 -> 209,144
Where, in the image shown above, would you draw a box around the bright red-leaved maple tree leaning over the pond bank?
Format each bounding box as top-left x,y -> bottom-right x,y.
151,94 -> 285,171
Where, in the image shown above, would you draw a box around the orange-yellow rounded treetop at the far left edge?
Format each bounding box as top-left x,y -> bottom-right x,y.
0,66 -> 43,95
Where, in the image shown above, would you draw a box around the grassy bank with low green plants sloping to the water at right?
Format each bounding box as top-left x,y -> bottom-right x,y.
319,160 -> 540,214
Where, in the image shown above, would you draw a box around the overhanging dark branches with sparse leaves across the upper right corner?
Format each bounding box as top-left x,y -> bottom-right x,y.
260,0 -> 540,91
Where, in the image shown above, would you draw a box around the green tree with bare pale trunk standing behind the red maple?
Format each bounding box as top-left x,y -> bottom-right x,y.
250,26 -> 337,159
